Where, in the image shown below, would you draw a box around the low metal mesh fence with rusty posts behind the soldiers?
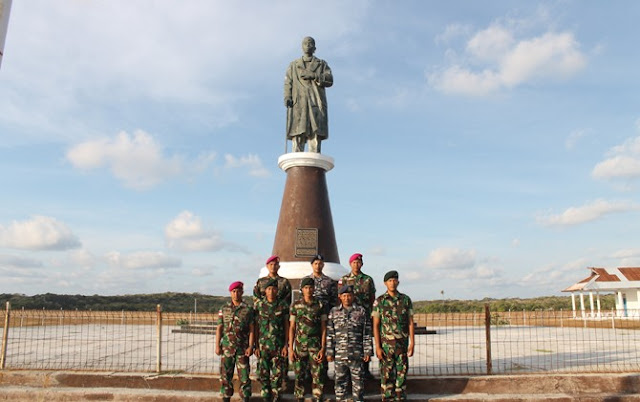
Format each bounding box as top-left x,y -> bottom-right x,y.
0,305 -> 640,376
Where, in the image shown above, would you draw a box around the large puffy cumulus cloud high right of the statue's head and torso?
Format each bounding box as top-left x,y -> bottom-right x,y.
427,23 -> 586,96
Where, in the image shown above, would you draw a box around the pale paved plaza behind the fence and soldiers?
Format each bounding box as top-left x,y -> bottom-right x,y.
5,324 -> 640,376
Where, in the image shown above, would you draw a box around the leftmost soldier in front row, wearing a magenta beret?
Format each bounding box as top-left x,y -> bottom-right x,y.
216,281 -> 254,402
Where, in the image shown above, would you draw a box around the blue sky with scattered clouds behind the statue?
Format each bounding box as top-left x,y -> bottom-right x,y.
0,0 -> 640,300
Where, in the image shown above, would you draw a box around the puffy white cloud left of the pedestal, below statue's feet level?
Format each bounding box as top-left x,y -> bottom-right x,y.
67,130 -> 183,190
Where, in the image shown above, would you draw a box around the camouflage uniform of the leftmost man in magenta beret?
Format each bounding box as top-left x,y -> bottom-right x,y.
218,301 -> 254,398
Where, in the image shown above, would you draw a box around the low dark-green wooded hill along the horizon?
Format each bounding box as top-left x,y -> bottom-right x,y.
0,292 -> 615,313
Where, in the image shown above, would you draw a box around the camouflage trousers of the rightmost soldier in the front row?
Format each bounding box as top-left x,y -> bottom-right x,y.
380,340 -> 409,401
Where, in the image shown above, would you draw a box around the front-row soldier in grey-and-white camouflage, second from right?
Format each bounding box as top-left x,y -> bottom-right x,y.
327,285 -> 373,402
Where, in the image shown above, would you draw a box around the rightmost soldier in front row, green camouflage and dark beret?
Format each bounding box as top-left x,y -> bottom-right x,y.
372,271 -> 415,401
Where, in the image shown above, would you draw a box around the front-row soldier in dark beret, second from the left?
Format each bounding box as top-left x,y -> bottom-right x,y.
254,278 -> 289,402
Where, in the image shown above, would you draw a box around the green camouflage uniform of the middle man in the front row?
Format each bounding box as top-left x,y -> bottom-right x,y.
291,299 -> 327,401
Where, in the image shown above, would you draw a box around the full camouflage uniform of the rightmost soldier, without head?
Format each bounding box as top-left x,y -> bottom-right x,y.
372,292 -> 413,401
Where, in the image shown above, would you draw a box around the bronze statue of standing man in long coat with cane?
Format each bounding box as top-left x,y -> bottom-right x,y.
284,36 -> 333,153
